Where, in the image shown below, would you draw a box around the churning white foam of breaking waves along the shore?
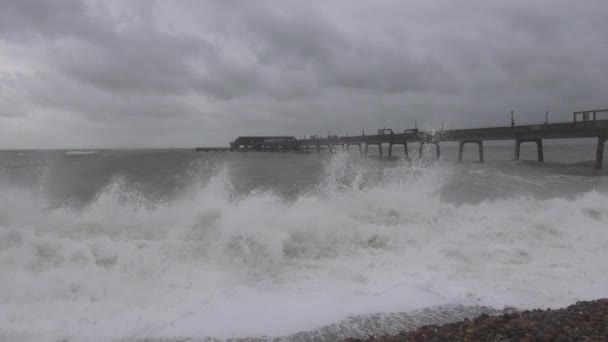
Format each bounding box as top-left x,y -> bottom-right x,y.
0,158 -> 608,341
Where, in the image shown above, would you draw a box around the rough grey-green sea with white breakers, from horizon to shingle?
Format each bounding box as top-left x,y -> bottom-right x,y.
0,141 -> 608,342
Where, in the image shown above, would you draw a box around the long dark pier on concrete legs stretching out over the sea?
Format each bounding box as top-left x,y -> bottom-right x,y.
202,109 -> 608,169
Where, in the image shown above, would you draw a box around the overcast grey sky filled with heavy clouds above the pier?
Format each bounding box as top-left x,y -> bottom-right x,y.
0,0 -> 608,149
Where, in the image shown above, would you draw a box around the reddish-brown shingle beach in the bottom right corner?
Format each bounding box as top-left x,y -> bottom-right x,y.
347,299 -> 608,342
